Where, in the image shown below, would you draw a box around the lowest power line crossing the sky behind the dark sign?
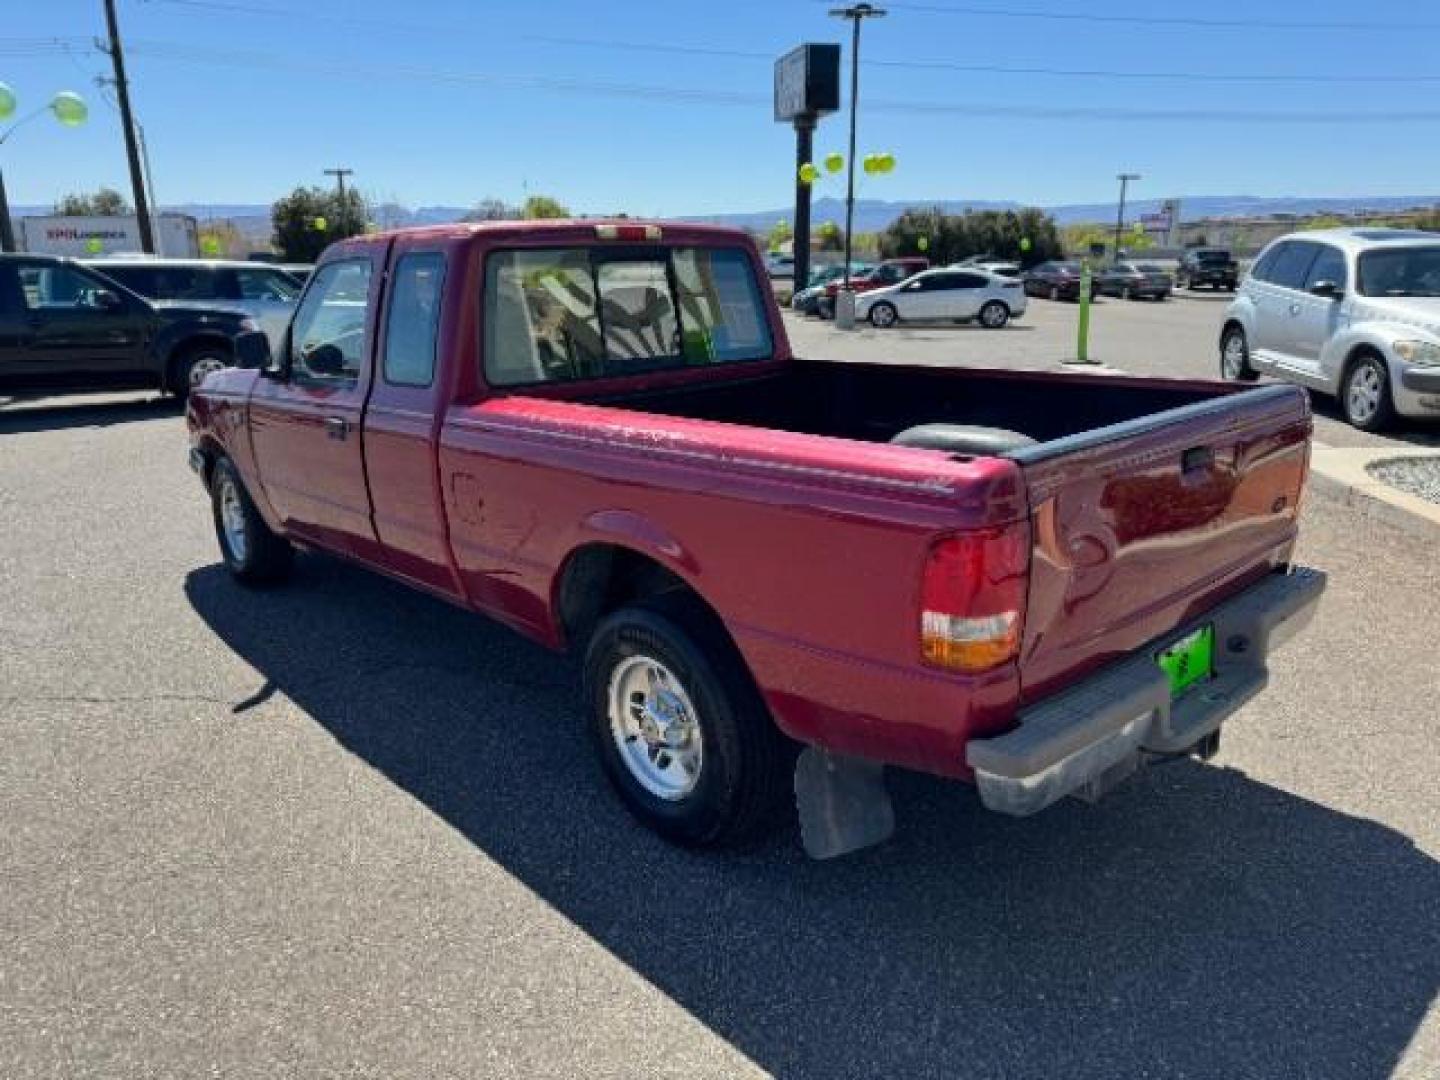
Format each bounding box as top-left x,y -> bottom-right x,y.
130,42 -> 1440,125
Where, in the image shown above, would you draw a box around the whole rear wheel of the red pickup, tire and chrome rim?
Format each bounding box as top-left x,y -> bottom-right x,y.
585,595 -> 793,847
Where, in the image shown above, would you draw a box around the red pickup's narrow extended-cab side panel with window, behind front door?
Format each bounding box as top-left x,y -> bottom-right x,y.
364,239 -> 465,598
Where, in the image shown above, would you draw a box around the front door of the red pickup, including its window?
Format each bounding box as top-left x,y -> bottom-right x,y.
251,253 -> 383,557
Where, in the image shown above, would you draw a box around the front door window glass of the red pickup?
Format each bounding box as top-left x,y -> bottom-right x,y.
289,259 -> 370,389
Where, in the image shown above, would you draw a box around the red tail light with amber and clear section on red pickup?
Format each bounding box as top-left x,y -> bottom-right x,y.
920,521 -> 1030,672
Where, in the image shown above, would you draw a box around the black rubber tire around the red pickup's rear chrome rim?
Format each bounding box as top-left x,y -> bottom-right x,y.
585,593 -> 795,847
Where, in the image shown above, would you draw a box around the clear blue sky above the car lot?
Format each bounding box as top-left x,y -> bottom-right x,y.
0,0 -> 1440,215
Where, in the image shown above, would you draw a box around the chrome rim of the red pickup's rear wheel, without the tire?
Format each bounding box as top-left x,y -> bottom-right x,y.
609,655 -> 704,802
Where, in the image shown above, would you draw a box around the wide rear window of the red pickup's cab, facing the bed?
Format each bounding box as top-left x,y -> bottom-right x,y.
485,248 -> 772,386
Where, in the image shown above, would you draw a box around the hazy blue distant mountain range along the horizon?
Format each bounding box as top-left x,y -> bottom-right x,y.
12,194 -> 1440,238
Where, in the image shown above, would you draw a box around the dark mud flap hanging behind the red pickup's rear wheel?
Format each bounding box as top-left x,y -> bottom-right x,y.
795,746 -> 896,858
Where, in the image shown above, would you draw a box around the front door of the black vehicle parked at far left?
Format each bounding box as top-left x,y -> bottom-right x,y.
17,261 -> 150,383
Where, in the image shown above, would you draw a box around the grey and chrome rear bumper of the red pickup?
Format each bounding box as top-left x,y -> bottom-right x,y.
966,567 -> 1325,816
